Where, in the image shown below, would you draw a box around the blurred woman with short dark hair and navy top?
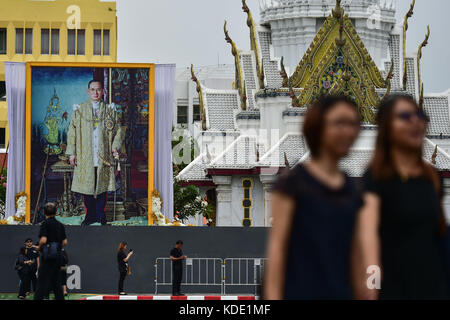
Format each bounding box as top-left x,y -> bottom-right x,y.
263,96 -> 362,300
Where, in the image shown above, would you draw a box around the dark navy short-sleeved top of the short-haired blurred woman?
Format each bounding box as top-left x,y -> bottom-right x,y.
273,165 -> 362,300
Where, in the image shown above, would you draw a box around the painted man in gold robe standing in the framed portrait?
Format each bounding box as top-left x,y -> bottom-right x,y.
66,80 -> 122,225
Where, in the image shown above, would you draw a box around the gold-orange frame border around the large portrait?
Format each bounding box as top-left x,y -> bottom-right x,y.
25,62 -> 155,225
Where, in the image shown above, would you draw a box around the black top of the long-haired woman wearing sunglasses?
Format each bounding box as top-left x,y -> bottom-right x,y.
364,171 -> 449,300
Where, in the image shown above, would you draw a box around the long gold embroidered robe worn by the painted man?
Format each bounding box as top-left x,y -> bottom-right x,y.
66,101 -> 122,195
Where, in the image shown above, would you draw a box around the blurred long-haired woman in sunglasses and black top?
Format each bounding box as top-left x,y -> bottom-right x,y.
354,95 -> 448,300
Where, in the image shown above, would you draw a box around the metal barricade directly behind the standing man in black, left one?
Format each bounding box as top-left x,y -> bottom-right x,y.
155,258 -> 223,294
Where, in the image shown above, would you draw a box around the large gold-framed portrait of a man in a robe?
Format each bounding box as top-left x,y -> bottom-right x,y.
25,62 -> 155,226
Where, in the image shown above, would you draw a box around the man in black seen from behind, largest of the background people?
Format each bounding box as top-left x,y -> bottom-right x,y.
34,203 -> 67,300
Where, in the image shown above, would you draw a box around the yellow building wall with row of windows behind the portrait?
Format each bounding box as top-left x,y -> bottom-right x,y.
0,0 -> 117,145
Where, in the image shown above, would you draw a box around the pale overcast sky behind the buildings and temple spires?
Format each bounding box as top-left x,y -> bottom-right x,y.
116,0 -> 450,93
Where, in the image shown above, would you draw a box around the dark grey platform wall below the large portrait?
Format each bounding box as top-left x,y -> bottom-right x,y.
0,225 -> 268,295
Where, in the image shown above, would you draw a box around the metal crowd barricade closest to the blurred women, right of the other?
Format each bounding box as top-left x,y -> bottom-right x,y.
223,258 -> 267,295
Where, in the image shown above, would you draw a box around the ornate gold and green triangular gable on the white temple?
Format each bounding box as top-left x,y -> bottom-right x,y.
285,0 -> 392,124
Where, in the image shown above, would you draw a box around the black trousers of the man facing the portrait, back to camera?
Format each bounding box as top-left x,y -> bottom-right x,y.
34,261 -> 64,300
